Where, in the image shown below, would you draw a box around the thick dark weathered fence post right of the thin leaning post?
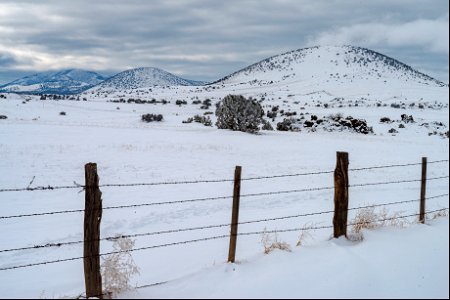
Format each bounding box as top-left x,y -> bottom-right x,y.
333,152 -> 349,238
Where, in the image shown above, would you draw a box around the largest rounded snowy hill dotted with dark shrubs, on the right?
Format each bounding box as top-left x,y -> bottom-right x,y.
209,46 -> 448,99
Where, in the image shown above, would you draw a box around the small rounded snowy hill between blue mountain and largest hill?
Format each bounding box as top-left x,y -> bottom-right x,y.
94,67 -> 204,90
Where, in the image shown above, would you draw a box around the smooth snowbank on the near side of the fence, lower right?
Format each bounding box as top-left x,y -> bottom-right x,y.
122,218 -> 449,299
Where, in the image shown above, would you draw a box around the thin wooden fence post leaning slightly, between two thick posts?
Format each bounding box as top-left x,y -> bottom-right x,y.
228,166 -> 242,263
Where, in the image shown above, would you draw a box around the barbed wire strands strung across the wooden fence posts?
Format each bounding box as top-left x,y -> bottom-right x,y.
0,155 -> 449,297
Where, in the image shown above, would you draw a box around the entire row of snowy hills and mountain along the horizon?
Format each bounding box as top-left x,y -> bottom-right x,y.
0,46 -> 448,94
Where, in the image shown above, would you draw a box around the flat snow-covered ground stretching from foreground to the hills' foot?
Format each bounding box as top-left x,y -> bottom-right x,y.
0,74 -> 449,298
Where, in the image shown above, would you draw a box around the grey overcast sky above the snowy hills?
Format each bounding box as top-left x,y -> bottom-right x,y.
0,0 -> 449,83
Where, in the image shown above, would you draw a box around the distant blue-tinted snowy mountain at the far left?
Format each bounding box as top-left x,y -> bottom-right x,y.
0,69 -> 106,94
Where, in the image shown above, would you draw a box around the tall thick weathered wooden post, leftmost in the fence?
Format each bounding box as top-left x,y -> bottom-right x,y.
83,163 -> 103,298
